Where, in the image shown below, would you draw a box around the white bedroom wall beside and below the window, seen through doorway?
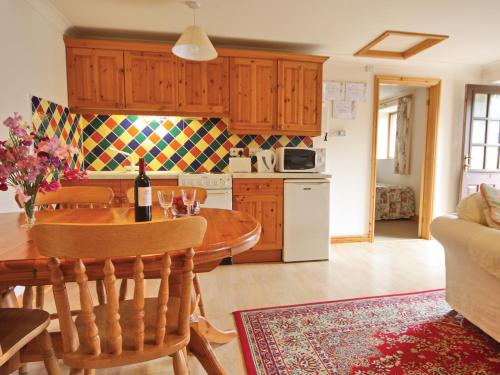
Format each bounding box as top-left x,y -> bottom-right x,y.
377,88 -> 427,214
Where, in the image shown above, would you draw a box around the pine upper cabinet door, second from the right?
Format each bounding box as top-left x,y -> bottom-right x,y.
230,58 -> 277,134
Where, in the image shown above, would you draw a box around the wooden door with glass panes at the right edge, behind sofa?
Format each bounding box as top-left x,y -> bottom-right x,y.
460,85 -> 500,198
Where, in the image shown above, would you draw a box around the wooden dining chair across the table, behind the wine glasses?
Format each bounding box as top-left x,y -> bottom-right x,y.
126,186 -> 207,316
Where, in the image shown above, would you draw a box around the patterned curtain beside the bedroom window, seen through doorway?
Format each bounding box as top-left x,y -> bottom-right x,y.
394,96 -> 411,174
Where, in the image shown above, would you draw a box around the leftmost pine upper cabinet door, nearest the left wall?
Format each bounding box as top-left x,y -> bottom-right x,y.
66,48 -> 124,109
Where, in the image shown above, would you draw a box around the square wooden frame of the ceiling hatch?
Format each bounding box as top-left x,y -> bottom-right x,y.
354,30 -> 449,60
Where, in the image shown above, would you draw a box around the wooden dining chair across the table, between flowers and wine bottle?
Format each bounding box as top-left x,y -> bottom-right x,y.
16,186 -> 114,309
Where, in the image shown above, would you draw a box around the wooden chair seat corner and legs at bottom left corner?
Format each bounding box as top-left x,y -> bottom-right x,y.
0,308 -> 60,375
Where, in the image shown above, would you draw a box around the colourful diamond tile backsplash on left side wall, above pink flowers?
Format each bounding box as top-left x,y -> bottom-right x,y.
31,96 -> 83,169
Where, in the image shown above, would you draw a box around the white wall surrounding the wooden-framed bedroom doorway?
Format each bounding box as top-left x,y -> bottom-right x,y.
315,60 -> 481,236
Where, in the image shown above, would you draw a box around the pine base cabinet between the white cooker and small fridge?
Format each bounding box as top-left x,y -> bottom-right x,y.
233,179 -> 283,263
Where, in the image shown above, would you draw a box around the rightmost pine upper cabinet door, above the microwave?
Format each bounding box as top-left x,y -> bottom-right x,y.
278,60 -> 323,135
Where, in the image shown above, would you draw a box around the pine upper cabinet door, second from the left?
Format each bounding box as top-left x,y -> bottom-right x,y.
124,51 -> 177,111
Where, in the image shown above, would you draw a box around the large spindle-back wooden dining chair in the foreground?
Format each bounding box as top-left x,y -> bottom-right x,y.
33,216 -> 207,375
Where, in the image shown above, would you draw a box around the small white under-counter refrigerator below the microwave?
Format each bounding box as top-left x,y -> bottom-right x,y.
283,178 -> 330,262
